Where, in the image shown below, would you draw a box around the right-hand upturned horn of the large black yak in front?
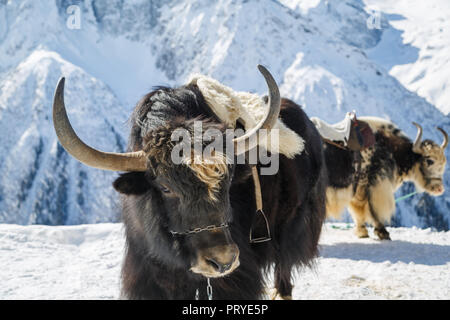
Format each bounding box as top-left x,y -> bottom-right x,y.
233,65 -> 281,155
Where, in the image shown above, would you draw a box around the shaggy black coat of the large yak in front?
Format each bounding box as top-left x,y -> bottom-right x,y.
114,85 -> 326,299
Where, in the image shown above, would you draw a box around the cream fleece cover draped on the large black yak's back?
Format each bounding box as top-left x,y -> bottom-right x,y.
188,74 -> 304,158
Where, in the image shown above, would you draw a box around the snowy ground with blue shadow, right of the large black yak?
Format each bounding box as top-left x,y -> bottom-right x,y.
294,223 -> 450,299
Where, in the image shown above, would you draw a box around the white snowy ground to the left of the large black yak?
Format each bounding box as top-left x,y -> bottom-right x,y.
0,223 -> 124,299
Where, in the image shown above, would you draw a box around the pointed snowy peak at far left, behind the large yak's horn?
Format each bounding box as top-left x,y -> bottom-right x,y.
0,50 -> 127,224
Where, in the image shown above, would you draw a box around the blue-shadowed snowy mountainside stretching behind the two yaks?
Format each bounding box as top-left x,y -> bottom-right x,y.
0,0 -> 450,230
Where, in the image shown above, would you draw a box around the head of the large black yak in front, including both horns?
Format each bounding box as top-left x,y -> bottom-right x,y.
53,66 -> 280,277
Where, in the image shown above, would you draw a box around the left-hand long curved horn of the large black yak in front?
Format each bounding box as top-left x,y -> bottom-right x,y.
53,78 -> 147,171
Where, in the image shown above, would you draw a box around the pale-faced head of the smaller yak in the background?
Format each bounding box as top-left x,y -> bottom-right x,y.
412,122 -> 448,196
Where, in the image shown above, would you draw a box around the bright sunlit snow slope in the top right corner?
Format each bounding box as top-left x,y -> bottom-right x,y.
365,0 -> 450,115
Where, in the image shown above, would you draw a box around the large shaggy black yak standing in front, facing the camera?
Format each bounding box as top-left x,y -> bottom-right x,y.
53,66 -> 326,299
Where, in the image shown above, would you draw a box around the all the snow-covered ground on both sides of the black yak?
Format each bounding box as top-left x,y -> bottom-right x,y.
0,223 -> 450,300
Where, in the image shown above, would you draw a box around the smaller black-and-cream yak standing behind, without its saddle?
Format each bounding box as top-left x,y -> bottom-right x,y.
324,117 -> 448,239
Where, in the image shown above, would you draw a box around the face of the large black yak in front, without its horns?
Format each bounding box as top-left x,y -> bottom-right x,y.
118,118 -> 239,278
